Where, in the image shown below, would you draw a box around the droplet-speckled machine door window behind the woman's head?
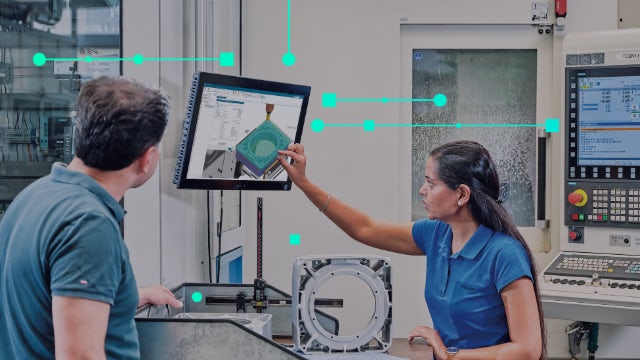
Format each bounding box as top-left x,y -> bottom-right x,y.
411,49 -> 537,226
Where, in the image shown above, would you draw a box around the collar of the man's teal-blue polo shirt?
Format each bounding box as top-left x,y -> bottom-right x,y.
51,162 -> 125,222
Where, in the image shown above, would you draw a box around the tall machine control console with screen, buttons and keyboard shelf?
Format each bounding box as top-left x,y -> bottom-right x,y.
538,29 -> 640,328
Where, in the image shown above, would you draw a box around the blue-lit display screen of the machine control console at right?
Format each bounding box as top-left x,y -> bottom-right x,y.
567,66 -> 640,177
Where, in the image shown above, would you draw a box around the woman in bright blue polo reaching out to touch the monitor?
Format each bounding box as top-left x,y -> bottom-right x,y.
280,141 -> 546,360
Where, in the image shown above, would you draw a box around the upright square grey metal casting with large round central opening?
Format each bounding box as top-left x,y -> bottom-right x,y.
292,255 -> 392,354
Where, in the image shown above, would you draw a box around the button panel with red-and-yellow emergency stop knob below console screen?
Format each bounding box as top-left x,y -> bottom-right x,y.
565,181 -> 640,228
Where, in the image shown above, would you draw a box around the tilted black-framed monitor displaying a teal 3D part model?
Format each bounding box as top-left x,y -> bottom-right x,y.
174,72 -> 311,190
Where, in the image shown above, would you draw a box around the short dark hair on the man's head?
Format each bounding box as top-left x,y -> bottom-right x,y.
74,77 -> 169,170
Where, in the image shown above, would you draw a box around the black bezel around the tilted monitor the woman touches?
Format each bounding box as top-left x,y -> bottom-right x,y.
176,71 -> 311,191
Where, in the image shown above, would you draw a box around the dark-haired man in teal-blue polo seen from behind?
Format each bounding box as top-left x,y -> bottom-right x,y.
0,77 -> 181,359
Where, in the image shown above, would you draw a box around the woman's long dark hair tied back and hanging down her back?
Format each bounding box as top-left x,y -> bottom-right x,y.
430,140 -> 547,359
